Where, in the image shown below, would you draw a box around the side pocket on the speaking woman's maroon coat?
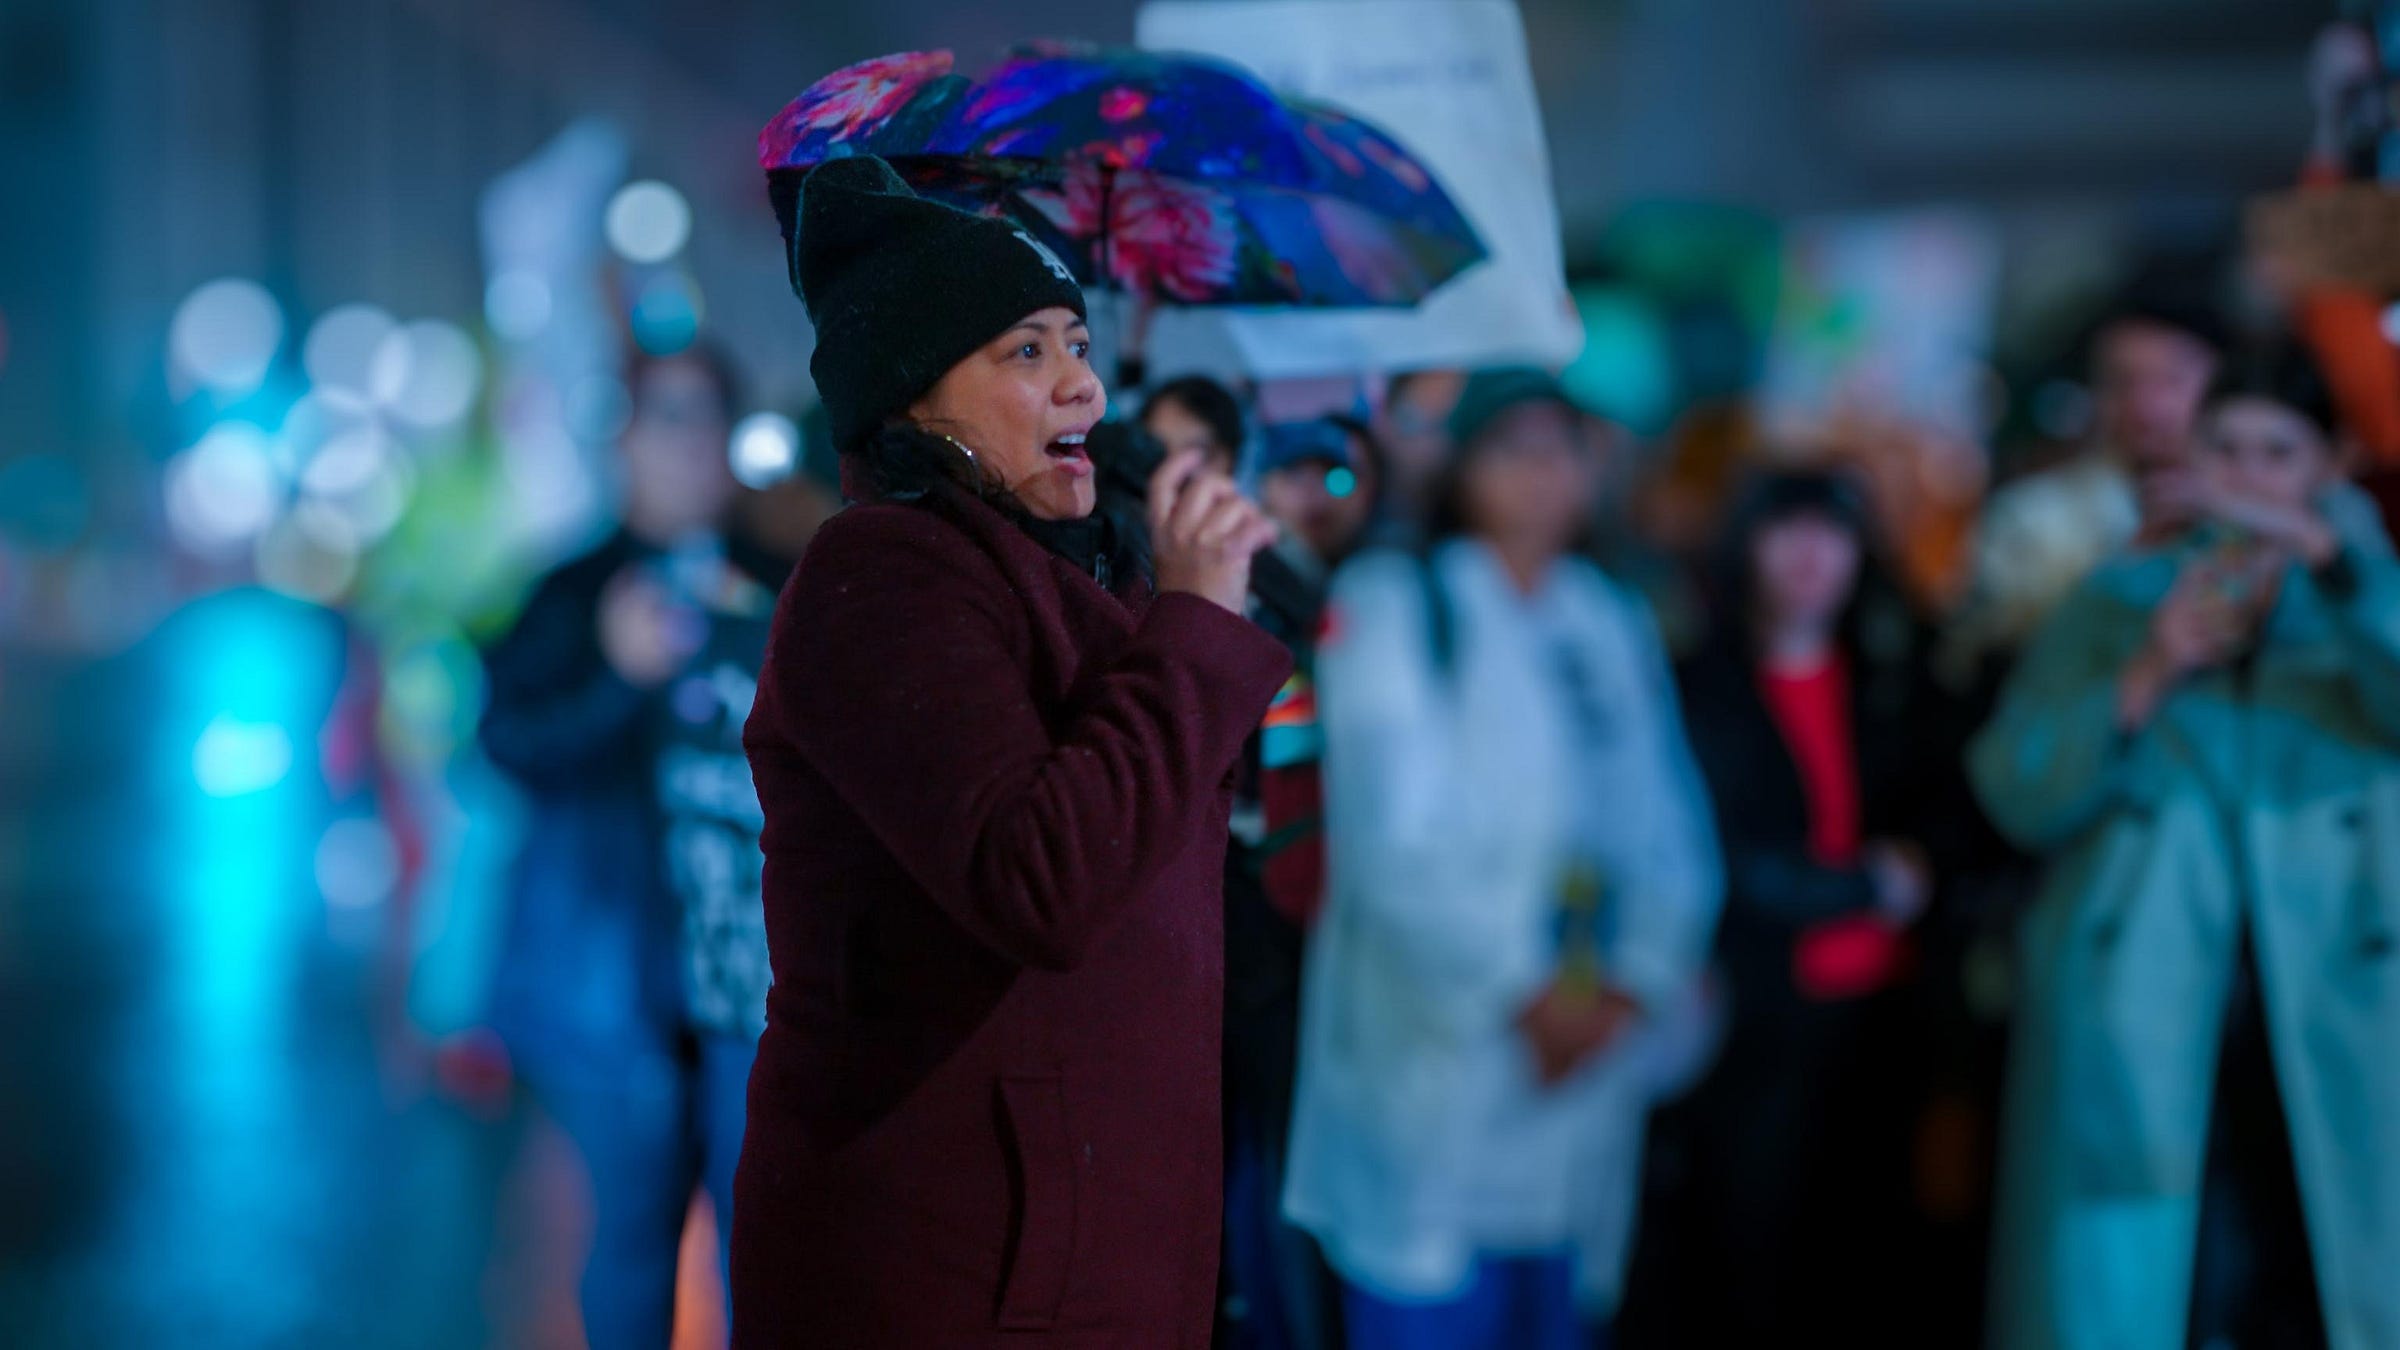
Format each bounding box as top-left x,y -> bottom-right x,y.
1001,1074 -> 1080,1331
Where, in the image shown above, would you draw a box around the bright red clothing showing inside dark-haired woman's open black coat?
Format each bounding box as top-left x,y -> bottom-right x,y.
1759,656 -> 1901,1002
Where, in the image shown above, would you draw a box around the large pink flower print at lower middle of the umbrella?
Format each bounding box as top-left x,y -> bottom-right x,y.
1025,173 -> 1236,303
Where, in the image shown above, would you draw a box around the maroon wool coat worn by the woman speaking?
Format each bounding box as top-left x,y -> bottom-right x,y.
732,478 -> 1289,1350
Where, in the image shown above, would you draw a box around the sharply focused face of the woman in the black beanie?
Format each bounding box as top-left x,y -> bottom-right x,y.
907,305 -> 1109,521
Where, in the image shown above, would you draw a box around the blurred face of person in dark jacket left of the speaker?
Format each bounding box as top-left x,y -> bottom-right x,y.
619,356 -> 739,543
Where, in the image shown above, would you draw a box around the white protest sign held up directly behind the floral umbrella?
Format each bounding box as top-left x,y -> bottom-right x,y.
1135,0 -> 1584,380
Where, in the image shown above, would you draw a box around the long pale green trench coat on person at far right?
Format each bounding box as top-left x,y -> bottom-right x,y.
1968,506 -> 2400,1350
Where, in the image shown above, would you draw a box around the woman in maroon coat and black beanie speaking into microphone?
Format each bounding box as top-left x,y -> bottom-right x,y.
732,156 -> 1289,1350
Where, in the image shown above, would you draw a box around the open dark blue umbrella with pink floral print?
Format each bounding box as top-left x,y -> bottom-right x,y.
758,43 -> 1486,307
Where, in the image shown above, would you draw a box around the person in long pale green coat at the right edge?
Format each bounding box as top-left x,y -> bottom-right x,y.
1968,353 -> 2400,1350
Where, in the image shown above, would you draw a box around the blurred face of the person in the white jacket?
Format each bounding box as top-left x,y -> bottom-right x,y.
1459,404 -> 1601,555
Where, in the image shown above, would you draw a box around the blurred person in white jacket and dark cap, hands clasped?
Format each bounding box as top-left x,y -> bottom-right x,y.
1284,370 -> 1718,1350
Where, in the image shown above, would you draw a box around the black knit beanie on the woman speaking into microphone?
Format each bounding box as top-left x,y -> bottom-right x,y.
770,156 -> 1085,454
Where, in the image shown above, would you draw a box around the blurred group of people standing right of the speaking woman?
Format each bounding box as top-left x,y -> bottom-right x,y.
1142,267 -> 2400,1345
